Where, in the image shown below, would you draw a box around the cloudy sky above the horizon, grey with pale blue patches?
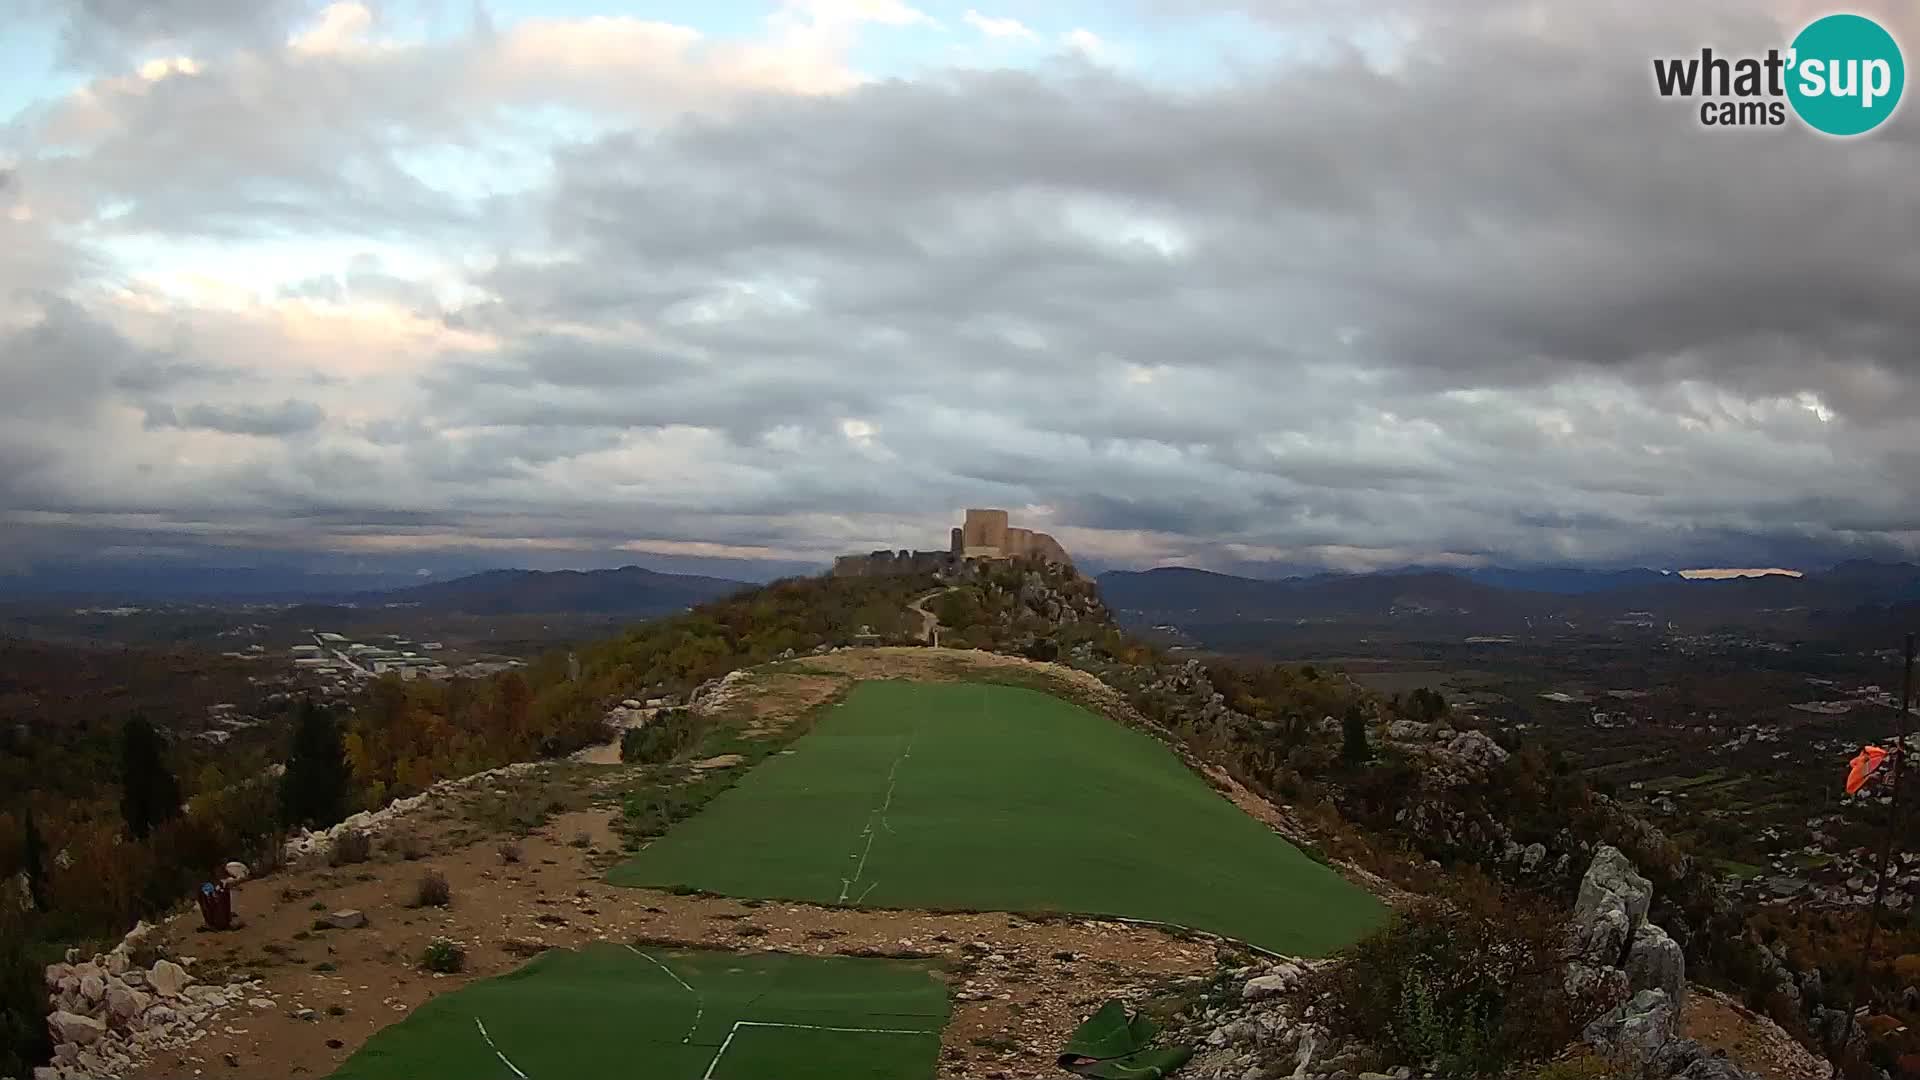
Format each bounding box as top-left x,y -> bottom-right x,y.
0,0 -> 1920,575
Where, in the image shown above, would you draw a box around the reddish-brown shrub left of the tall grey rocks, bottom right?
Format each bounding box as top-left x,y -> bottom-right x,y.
1319,884 -> 1574,1076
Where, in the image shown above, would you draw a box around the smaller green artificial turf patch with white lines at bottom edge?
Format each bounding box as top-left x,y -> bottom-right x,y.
330,944 -> 948,1080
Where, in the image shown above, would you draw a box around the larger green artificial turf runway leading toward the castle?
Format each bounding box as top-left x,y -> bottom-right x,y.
609,682 -> 1384,955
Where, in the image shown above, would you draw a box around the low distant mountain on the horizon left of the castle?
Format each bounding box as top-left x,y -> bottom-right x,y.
353,567 -> 753,615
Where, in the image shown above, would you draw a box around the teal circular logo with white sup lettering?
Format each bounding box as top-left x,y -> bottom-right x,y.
1788,15 -> 1907,135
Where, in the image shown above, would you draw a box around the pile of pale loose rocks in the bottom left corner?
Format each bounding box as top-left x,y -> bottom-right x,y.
33,922 -> 273,1080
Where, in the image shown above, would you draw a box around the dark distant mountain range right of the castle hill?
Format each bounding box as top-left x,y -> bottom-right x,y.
1098,561 -> 1920,632
